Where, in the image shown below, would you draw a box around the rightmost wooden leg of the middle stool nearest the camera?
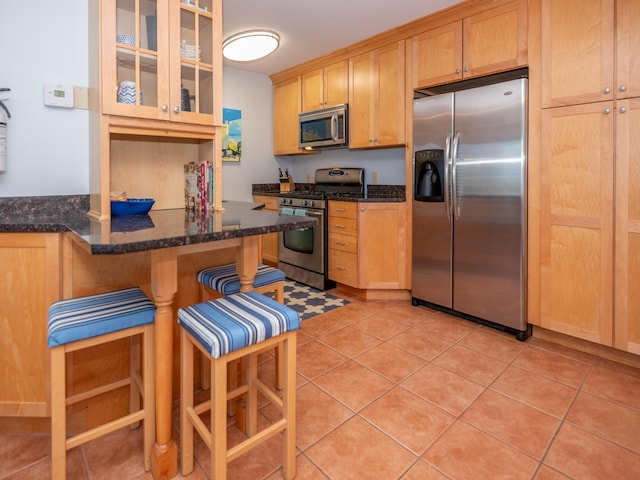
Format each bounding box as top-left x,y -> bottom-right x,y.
280,331 -> 296,480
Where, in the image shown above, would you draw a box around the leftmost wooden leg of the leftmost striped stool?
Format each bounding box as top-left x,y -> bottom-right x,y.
51,346 -> 67,480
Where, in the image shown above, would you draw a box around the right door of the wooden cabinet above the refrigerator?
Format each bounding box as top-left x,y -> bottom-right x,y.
462,2 -> 527,78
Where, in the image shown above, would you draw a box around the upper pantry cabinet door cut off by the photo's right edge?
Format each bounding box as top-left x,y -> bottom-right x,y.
616,0 -> 640,98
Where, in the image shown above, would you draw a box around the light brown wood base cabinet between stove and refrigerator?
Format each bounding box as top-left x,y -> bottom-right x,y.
329,201 -> 406,290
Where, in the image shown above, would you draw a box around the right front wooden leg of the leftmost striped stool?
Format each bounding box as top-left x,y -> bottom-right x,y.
142,325 -> 156,471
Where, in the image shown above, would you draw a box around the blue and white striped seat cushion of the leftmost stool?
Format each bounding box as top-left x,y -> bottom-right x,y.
47,287 -> 156,347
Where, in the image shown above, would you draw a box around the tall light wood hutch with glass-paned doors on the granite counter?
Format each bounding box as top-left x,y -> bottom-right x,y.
89,0 -> 222,219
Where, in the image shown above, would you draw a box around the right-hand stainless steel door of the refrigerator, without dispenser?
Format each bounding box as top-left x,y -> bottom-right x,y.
452,79 -> 526,330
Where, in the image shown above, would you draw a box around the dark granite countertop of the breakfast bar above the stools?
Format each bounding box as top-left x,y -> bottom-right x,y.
0,197 -> 316,254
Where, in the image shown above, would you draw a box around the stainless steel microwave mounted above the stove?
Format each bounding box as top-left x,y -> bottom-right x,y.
298,103 -> 349,148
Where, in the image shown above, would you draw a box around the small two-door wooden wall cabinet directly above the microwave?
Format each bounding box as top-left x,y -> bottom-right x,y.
302,60 -> 349,112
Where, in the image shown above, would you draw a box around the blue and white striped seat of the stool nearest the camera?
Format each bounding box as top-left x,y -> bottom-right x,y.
178,292 -> 300,358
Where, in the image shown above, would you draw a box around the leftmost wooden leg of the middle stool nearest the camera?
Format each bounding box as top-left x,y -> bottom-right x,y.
180,329 -> 193,475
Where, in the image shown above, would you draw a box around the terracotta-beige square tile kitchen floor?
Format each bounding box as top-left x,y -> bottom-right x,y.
0,292 -> 640,480
